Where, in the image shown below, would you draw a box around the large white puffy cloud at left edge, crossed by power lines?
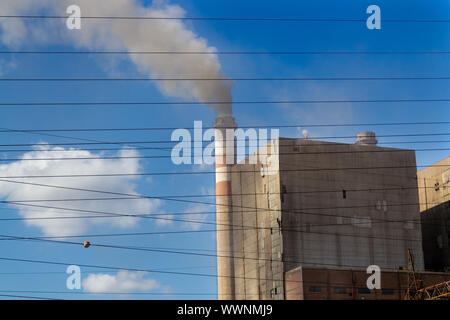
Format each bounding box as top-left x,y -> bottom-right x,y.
0,145 -> 160,236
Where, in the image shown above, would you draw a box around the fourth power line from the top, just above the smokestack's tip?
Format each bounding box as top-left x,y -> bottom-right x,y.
0,98 -> 450,107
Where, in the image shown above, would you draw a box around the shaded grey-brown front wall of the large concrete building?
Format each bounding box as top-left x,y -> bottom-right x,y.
280,139 -> 424,271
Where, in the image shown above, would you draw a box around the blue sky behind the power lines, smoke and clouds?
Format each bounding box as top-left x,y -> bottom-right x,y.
0,0 -> 450,299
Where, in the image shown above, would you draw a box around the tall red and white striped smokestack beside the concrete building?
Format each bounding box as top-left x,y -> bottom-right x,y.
214,116 -> 236,300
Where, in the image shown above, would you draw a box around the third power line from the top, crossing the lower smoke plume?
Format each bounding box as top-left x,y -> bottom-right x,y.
0,76 -> 450,82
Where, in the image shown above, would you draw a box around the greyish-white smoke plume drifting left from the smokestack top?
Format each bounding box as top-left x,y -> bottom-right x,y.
0,0 -> 231,115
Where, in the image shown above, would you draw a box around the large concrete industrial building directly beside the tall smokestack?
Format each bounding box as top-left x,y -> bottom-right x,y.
216,128 -> 424,299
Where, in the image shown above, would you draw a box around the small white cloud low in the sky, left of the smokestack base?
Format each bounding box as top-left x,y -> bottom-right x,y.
82,270 -> 168,293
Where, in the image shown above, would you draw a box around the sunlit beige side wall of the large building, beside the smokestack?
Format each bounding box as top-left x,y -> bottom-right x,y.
231,140 -> 284,299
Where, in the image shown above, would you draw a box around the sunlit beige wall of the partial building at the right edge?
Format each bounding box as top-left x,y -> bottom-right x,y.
417,157 -> 450,212
